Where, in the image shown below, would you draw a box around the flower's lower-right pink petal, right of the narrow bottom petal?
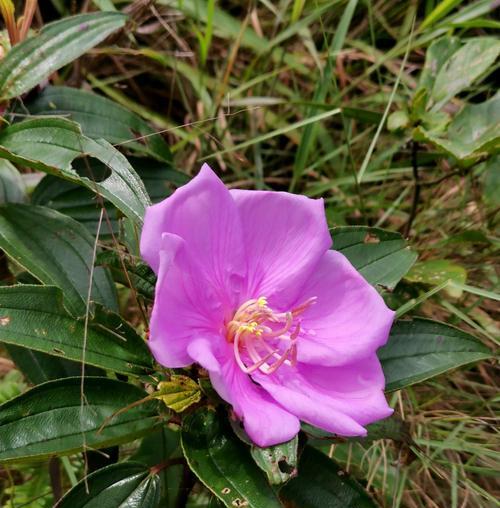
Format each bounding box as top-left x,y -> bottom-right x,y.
253,355 -> 393,436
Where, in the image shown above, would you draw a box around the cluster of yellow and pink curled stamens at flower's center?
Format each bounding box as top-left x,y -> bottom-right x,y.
227,296 -> 317,374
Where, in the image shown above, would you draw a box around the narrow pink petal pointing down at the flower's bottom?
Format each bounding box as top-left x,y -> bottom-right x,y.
206,345 -> 300,447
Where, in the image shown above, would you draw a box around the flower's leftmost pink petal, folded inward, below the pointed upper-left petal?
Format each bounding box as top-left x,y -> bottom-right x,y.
148,233 -> 224,368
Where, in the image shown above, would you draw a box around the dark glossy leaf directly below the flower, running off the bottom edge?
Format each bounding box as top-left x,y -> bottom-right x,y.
181,408 -> 281,508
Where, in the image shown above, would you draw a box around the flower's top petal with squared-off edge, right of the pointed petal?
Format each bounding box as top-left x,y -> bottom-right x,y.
231,190 -> 332,307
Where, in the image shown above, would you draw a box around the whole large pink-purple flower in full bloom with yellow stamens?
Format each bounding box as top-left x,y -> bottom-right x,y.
141,164 -> 394,446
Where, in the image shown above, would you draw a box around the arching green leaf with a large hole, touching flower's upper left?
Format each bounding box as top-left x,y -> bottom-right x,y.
0,117 -> 150,224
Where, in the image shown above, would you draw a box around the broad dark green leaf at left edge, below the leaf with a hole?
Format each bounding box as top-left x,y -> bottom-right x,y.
0,205 -> 118,316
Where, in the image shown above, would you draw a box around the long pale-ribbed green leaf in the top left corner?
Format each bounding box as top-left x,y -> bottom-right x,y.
0,12 -> 127,102
